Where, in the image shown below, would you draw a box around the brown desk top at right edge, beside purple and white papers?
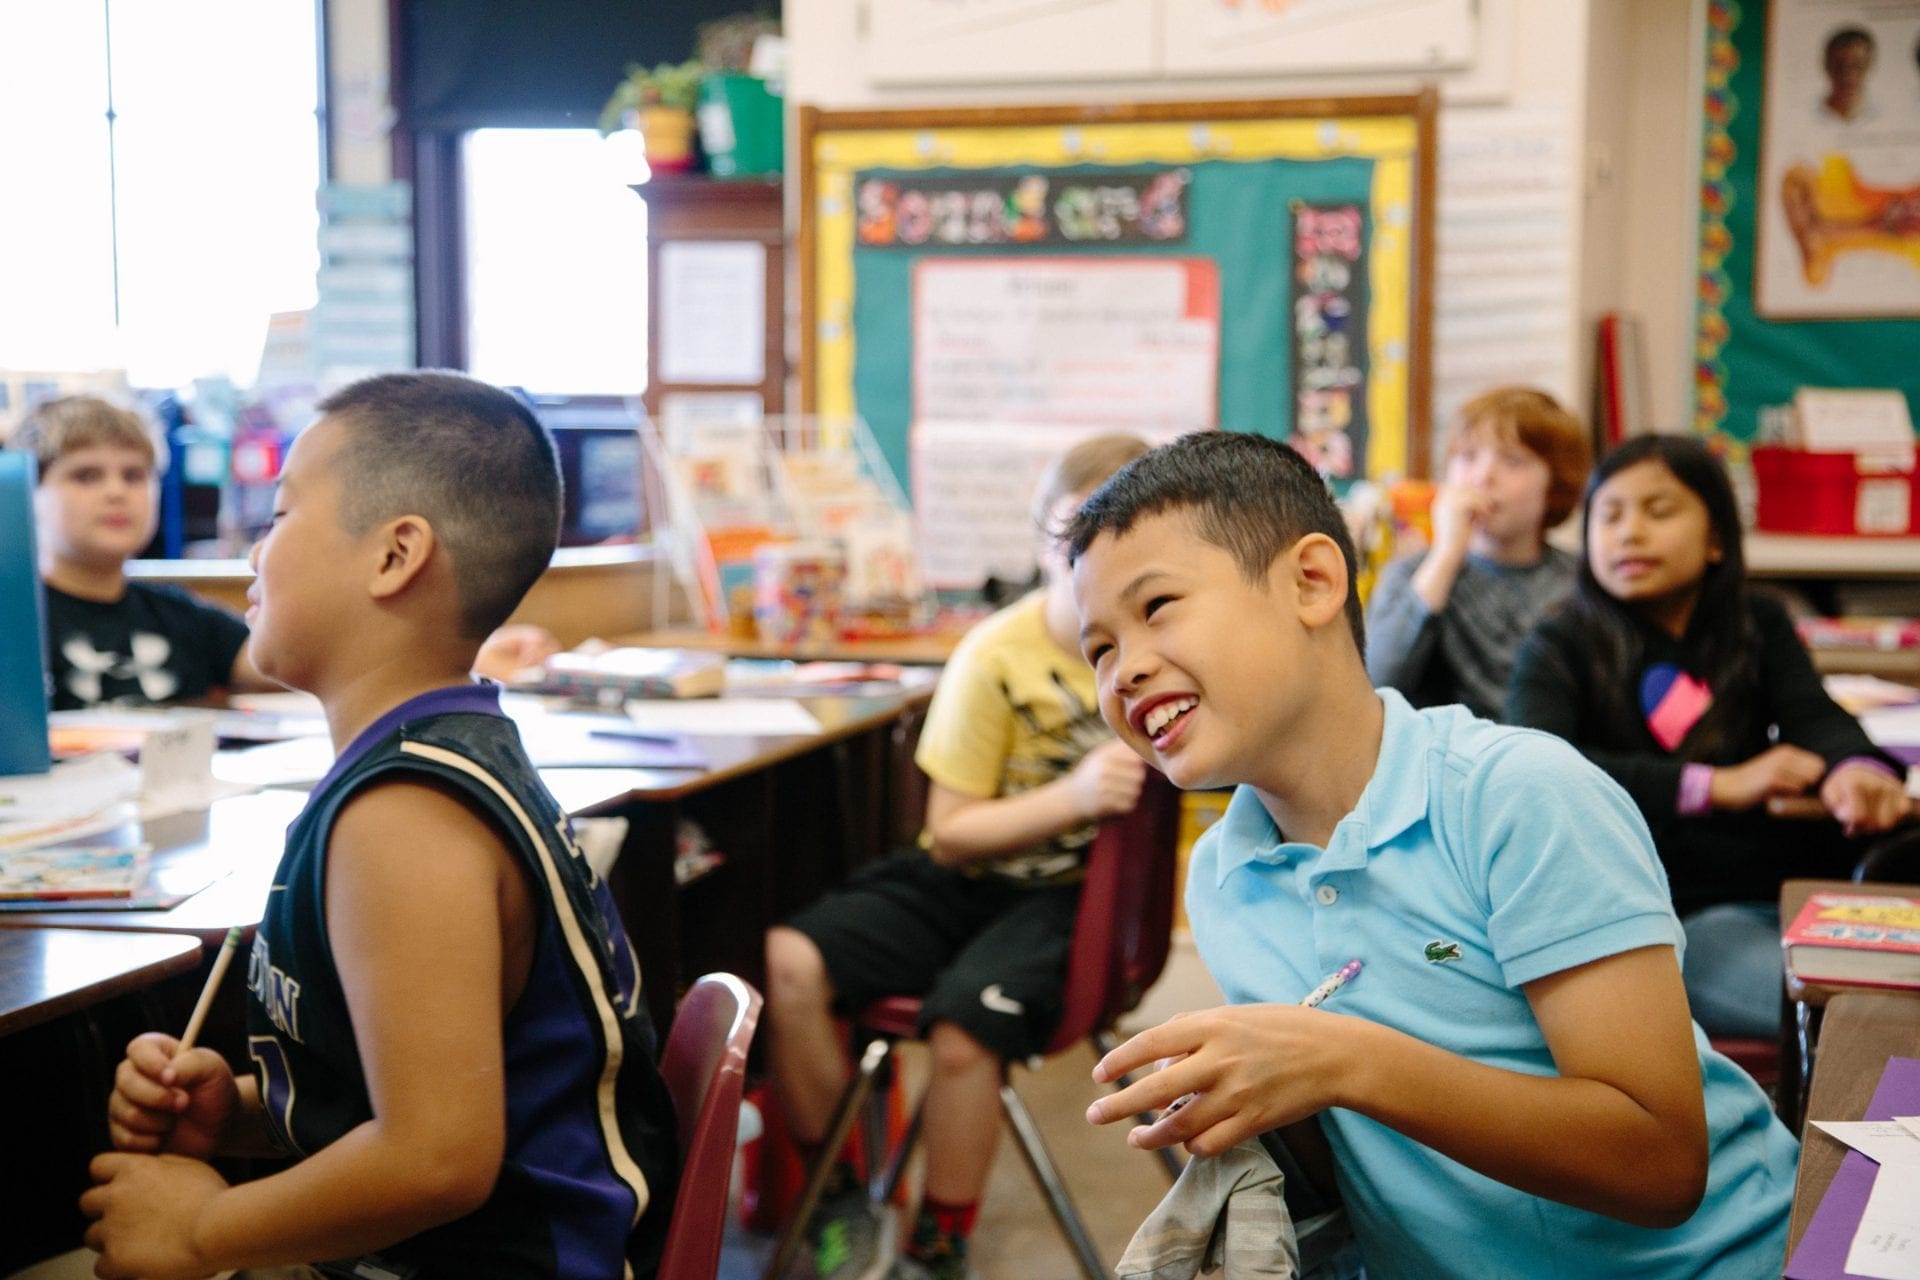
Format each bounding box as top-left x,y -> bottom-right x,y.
1788,990 -> 1920,1257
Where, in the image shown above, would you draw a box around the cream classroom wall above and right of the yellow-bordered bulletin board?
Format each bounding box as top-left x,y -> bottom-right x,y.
785,0 -> 1703,460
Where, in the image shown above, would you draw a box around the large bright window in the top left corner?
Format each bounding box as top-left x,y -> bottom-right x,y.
0,0 -> 321,388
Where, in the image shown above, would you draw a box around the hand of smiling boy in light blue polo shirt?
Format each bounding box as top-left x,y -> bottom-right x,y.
1087,1004 -> 1354,1155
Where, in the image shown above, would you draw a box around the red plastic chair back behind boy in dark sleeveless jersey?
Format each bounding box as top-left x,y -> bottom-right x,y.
657,973 -> 760,1280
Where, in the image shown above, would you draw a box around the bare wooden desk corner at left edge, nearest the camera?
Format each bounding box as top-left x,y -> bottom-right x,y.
0,929 -> 200,1036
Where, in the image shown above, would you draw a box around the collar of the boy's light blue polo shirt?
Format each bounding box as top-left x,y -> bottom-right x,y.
1215,689 -> 1432,887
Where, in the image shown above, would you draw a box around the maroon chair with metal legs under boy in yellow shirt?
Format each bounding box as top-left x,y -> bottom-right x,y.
764,771 -> 1181,1280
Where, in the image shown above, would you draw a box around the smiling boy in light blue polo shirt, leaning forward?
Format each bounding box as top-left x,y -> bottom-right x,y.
1068,432 -> 1797,1280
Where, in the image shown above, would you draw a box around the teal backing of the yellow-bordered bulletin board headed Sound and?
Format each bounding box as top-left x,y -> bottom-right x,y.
852,155 -> 1373,489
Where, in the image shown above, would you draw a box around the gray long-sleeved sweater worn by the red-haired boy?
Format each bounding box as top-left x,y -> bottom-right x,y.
1367,547 -> 1578,720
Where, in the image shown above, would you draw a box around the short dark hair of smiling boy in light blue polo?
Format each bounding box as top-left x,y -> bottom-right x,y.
1062,432 -> 1367,656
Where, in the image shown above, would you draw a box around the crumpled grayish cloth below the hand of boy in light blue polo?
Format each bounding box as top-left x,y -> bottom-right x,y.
1114,1138 -> 1300,1280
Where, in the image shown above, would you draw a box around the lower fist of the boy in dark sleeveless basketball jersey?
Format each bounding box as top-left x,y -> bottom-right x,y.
81,1153 -> 227,1280
